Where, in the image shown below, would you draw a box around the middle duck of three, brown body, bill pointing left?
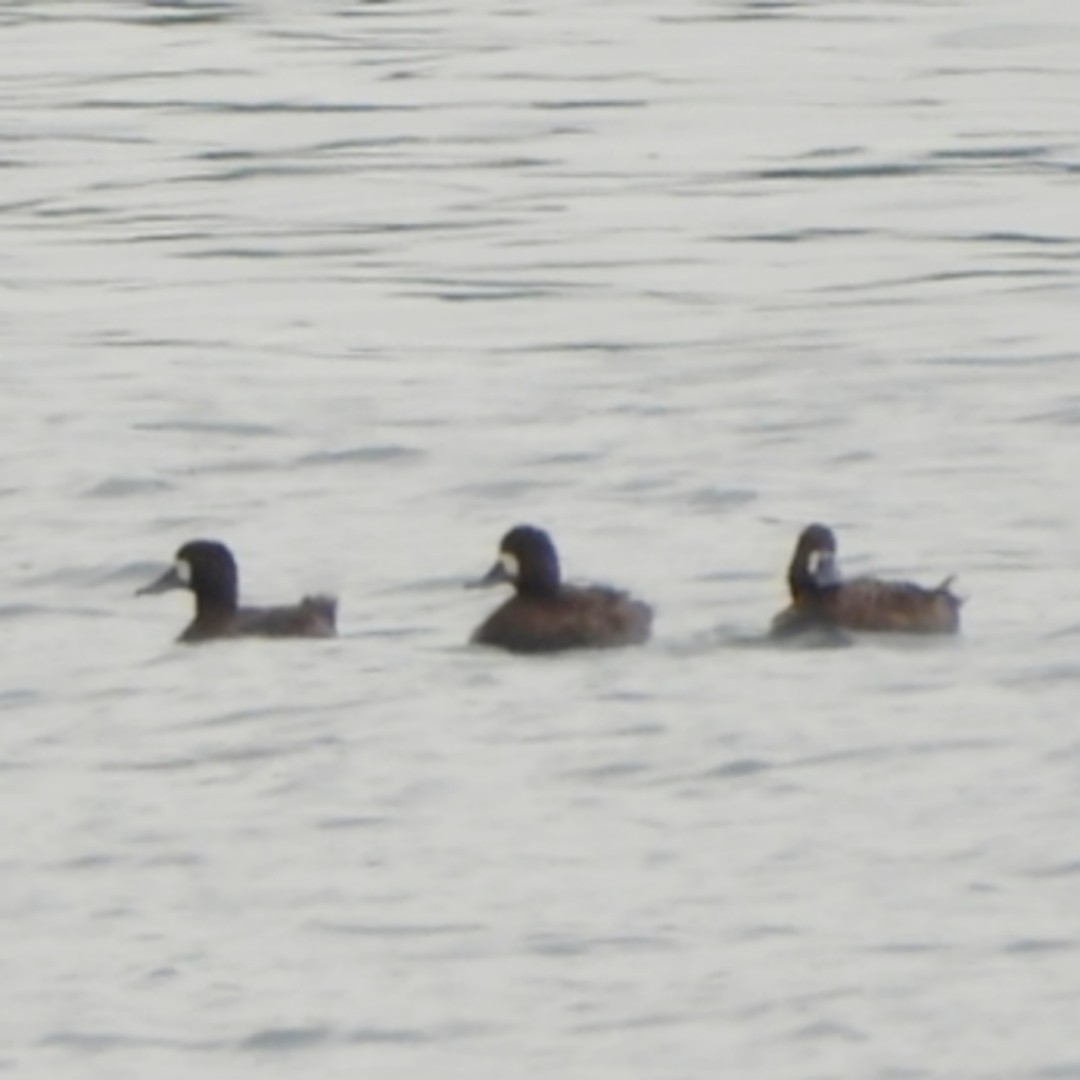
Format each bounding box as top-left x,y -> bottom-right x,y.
472,525 -> 652,652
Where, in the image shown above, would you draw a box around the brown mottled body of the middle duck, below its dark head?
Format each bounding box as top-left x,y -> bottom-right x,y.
472,585 -> 652,652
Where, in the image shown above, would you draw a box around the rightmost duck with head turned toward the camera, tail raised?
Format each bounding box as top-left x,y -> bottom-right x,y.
771,524 -> 963,637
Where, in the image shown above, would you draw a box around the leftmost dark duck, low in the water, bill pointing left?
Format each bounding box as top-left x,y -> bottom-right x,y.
136,540 -> 337,645
